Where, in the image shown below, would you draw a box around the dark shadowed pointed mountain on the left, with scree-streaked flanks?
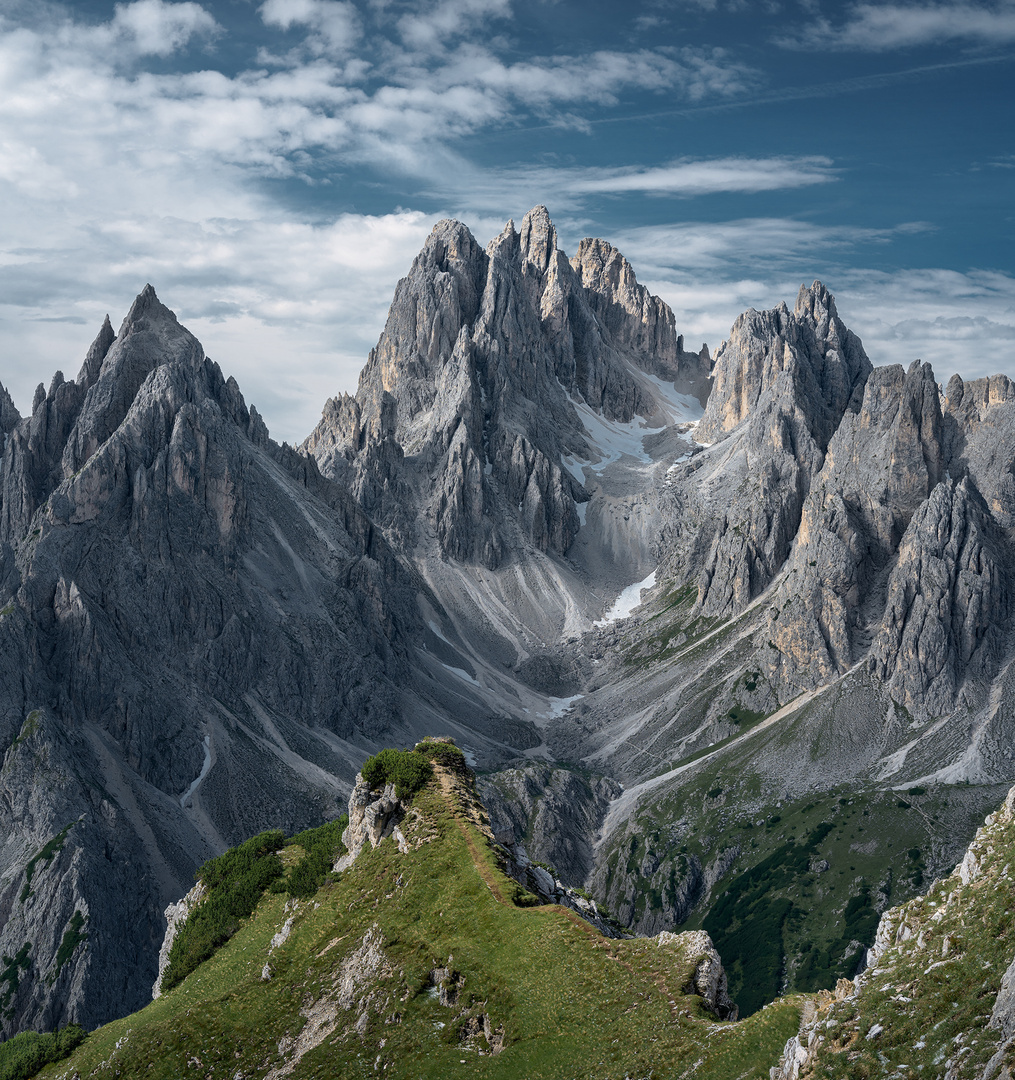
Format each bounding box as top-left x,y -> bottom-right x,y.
0,288 -> 468,1034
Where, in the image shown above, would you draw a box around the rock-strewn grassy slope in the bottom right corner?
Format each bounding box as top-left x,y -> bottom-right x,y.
768,788 -> 1015,1080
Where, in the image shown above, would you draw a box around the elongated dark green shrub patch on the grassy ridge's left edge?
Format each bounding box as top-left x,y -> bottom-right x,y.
162,829 -> 285,993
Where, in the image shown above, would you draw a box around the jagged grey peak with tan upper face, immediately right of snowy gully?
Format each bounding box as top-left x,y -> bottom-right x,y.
664,282 -> 871,618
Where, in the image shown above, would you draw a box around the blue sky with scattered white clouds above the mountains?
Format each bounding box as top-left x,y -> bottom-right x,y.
0,0 -> 1015,442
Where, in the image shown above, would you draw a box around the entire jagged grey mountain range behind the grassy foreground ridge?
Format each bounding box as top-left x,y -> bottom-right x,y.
0,206 -> 1015,1035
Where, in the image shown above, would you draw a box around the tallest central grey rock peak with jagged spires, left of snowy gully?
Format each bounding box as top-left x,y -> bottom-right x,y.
305,206 -> 707,569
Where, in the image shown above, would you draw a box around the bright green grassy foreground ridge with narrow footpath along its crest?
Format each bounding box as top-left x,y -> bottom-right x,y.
35,765 -> 800,1080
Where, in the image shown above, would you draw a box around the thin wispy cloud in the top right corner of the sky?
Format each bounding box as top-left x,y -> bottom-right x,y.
779,2 -> 1015,52
